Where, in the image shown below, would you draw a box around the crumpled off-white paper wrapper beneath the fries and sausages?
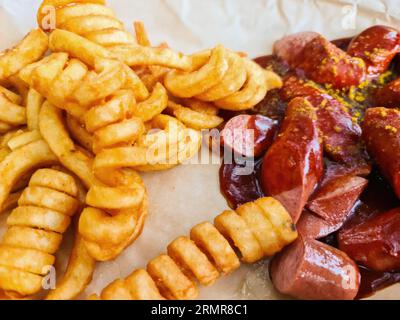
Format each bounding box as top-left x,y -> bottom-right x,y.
0,0 -> 400,299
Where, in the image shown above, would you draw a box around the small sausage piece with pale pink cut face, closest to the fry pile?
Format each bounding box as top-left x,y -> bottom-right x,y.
221,115 -> 277,157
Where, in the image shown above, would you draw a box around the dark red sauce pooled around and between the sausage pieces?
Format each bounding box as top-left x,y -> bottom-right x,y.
220,38 -> 400,299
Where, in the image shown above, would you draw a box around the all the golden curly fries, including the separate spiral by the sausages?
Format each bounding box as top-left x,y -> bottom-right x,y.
0,0 -> 286,299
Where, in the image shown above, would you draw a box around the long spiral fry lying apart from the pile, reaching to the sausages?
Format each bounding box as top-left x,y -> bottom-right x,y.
90,198 -> 297,300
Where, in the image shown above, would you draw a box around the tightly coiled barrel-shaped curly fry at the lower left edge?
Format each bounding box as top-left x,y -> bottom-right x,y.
0,169 -> 78,295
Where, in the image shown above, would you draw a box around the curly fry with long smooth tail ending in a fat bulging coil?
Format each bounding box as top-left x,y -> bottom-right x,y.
39,102 -> 147,261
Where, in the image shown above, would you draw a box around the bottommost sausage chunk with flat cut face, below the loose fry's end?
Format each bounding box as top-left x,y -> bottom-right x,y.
271,236 -> 360,300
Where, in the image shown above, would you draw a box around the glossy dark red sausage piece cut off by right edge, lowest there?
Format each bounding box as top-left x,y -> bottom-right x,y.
338,208 -> 400,271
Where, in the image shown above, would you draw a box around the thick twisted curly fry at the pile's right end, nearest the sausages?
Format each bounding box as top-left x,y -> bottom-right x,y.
164,45 -> 282,111
